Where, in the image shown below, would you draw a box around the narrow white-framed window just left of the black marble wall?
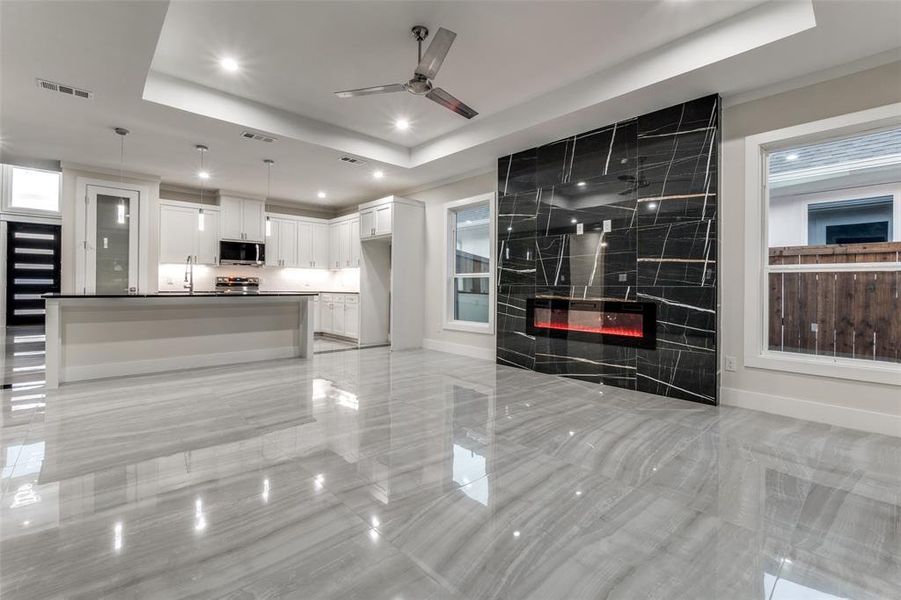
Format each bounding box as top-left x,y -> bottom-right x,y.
445,194 -> 494,333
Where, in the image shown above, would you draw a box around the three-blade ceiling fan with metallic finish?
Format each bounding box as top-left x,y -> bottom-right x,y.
335,25 -> 479,119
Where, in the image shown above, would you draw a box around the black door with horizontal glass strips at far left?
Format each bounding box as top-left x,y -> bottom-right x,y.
6,222 -> 60,326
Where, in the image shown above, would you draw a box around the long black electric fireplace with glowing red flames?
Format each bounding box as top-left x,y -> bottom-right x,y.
526,298 -> 657,350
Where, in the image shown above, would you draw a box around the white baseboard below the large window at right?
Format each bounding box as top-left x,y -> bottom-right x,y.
720,387 -> 901,437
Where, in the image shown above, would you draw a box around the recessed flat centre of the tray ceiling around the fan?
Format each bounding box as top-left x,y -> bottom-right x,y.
151,0 -> 762,147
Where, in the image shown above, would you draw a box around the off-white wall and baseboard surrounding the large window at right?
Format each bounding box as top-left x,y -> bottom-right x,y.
719,62 -> 901,435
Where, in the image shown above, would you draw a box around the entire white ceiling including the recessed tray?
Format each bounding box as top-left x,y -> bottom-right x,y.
0,0 -> 901,207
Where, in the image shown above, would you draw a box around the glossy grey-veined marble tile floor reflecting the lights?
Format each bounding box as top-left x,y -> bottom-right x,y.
0,348 -> 901,600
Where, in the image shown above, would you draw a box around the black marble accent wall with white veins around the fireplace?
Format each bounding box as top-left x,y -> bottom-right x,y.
497,95 -> 720,404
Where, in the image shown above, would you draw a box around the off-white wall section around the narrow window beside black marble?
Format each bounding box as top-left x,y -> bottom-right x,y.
402,169 -> 497,359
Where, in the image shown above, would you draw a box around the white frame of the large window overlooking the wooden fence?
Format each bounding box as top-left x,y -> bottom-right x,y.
743,103 -> 901,386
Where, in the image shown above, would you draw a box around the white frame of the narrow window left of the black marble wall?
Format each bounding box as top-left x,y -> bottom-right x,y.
443,192 -> 496,335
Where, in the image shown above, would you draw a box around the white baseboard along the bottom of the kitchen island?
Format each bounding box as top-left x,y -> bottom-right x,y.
60,346 -> 300,383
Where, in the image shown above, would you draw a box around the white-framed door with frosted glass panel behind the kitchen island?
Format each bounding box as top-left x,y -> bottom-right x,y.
76,185 -> 140,294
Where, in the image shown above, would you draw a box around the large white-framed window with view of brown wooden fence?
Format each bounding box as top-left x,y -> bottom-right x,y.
745,107 -> 901,385
